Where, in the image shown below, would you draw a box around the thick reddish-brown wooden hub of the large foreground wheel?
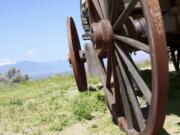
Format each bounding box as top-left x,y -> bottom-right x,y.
92,19 -> 113,49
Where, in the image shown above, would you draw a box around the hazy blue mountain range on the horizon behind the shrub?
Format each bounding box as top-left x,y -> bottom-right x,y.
0,60 -> 72,79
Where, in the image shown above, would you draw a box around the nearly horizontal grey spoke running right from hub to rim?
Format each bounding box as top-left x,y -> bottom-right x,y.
114,34 -> 150,53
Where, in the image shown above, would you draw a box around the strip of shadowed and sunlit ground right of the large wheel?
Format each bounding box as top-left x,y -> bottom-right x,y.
164,72 -> 180,135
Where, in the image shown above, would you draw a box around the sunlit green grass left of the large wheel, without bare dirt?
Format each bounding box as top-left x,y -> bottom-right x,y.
0,76 -> 124,135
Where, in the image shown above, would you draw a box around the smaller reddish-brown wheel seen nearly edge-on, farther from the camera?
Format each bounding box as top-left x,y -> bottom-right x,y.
67,17 -> 87,91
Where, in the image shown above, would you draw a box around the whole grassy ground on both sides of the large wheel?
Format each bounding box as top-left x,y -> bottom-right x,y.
0,73 -> 180,135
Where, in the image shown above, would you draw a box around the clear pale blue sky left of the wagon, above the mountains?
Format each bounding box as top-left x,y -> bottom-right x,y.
0,0 -> 83,62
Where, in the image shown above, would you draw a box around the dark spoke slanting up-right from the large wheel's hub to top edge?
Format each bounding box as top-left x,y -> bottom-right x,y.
113,0 -> 139,30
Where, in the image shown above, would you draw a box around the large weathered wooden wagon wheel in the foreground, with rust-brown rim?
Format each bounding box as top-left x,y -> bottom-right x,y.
87,0 -> 168,135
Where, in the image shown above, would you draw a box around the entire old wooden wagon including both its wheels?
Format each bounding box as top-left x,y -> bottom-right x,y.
67,0 -> 180,135
